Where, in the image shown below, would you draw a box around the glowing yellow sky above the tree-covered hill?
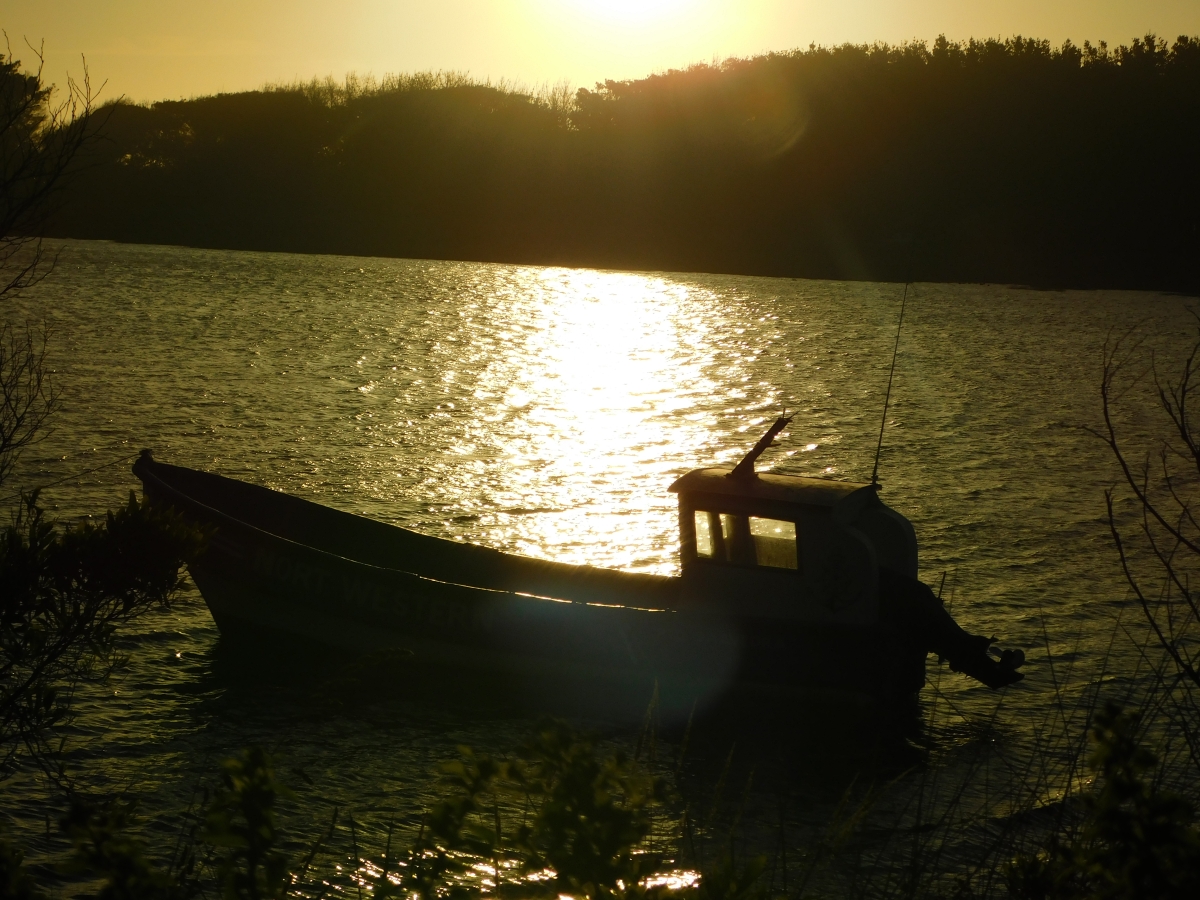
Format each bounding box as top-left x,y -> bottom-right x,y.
0,0 -> 1200,102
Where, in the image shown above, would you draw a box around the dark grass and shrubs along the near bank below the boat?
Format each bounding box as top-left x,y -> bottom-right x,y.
2,629 -> 1200,900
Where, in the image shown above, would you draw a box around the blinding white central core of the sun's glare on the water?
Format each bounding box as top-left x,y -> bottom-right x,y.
472,270 -> 734,569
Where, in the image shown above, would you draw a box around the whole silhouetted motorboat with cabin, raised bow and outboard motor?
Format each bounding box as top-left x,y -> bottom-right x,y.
133,419 -> 1020,710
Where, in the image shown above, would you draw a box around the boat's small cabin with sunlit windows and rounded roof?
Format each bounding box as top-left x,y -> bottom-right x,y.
670,424 -> 917,625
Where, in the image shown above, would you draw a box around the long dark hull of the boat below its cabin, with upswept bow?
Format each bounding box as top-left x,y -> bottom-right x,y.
134,458 -> 924,707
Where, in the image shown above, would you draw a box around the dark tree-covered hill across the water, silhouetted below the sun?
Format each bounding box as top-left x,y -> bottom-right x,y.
53,37 -> 1200,292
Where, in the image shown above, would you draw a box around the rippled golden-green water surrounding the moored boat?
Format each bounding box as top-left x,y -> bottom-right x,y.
0,242 -> 1194,897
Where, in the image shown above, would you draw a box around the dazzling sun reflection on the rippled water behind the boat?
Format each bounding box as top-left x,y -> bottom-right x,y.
379,269 -> 776,572
